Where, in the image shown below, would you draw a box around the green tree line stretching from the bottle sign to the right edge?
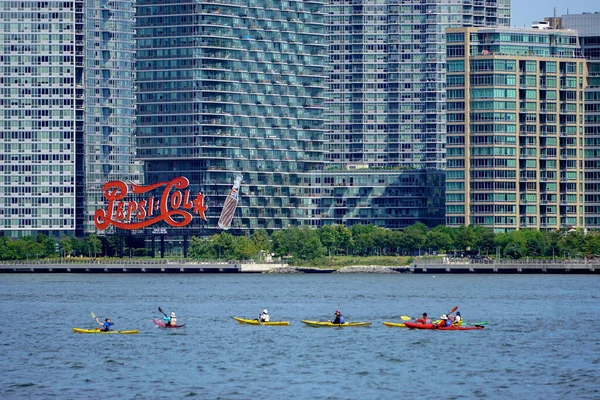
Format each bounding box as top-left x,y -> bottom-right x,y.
189,223 -> 600,262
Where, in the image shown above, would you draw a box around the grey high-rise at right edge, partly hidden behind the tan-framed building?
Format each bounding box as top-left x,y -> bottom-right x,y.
560,12 -> 600,229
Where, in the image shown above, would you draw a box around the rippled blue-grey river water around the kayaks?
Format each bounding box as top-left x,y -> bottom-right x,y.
0,274 -> 600,399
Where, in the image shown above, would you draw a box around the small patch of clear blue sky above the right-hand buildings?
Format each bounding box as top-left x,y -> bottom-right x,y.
511,0 -> 600,28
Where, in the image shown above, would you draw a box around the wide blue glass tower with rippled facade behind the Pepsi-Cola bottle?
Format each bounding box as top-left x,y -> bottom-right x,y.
136,0 -> 327,230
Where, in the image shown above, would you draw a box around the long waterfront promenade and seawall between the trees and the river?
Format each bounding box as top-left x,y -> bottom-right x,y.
0,259 -> 600,274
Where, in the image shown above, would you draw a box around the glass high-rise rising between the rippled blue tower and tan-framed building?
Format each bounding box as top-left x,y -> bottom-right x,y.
327,0 -> 510,170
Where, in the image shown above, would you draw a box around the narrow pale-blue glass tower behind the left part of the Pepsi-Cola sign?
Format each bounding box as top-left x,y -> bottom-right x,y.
80,0 -> 141,232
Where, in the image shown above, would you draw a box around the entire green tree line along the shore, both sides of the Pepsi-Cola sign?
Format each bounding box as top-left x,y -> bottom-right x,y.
0,223 -> 600,262
